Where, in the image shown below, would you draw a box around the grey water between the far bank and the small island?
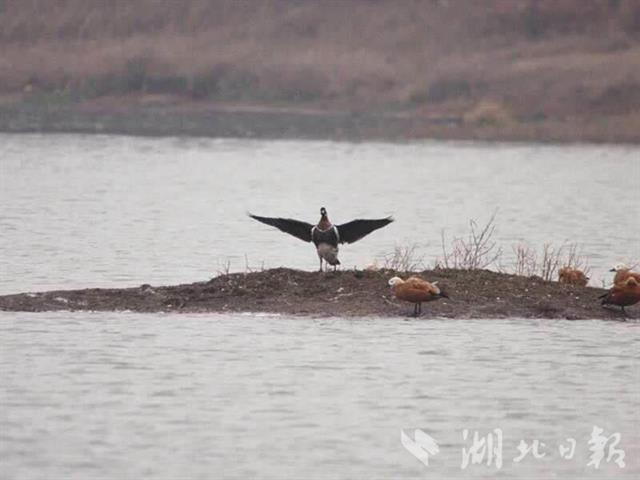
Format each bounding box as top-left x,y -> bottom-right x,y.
0,135 -> 640,294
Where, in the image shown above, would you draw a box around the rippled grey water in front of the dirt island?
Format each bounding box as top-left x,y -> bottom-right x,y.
0,313 -> 640,479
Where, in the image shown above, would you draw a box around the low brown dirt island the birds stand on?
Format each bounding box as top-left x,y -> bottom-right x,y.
0,268 -> 640,320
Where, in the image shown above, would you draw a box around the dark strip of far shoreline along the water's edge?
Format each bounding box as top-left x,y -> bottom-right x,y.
0,99 -> 640,145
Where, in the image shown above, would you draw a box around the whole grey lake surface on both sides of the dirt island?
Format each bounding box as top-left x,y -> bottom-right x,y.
0,134 -> 640,479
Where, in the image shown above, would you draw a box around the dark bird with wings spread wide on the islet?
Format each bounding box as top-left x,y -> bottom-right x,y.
248,207 -> 393,272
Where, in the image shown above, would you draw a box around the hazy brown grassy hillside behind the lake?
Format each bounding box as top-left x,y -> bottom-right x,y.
0,0 -> 640,141
